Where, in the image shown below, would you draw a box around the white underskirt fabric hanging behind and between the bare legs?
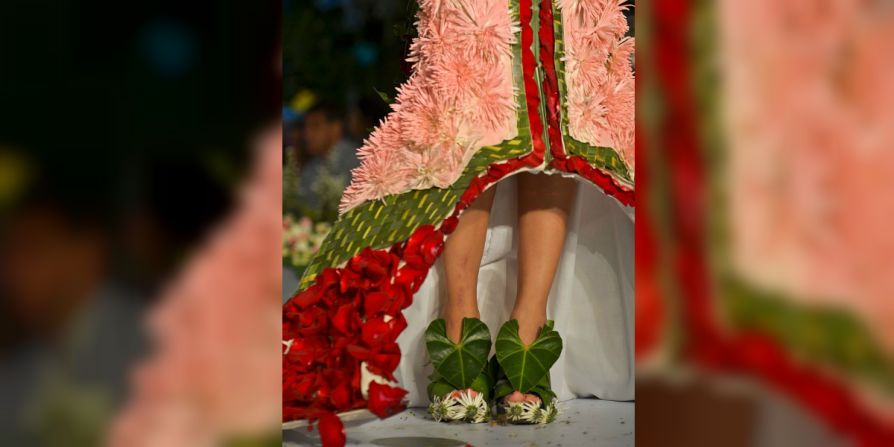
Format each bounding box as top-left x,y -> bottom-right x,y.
395,177 -> 634,407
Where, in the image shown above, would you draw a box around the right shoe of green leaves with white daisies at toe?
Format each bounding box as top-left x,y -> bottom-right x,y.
490,320 -> 562,424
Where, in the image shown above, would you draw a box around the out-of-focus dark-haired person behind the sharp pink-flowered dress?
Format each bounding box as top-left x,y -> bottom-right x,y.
298,103 -> 360,219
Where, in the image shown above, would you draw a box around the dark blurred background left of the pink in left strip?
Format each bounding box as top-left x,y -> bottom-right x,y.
0,0 -> 281,446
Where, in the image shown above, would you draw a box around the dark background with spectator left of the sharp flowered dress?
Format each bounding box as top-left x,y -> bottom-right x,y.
282,0 -> 417,300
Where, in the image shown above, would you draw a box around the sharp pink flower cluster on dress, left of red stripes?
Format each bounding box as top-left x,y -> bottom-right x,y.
340,0 -> 518,213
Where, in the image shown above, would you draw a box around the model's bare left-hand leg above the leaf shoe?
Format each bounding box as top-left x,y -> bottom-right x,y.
443,187 -> 496,342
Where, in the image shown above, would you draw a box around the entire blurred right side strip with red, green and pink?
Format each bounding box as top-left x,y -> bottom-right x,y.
636,0 -> 894,446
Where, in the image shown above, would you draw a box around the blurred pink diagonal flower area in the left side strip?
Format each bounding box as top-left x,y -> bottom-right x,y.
109,127 -> 283,447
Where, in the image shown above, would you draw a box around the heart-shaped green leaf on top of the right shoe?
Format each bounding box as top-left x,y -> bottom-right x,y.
496,320 -> 562,393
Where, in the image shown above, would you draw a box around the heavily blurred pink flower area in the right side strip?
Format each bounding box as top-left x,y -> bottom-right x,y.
718,0 -> 894,354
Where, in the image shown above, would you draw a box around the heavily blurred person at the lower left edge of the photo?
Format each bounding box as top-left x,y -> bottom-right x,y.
0,187 -> 143,445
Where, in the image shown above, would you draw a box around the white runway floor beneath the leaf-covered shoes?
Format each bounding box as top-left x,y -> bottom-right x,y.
283,399 -> 634,447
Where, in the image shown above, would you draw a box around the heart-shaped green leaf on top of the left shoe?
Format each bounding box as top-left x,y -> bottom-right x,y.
425,318 -> 491,389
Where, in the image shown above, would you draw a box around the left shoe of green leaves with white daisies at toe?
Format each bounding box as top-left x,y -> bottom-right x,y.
425,318 -> 494,423
